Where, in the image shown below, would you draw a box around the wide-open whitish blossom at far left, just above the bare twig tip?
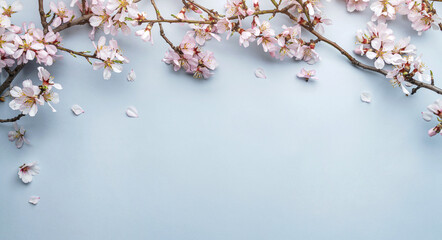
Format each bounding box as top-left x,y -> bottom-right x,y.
9,80 -> 44,117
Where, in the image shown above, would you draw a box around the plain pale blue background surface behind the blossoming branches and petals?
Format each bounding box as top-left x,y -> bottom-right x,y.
0,0 -> 442,240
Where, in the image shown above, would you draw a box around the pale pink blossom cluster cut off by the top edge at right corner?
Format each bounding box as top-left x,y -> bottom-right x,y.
346,0 -> 442,35
